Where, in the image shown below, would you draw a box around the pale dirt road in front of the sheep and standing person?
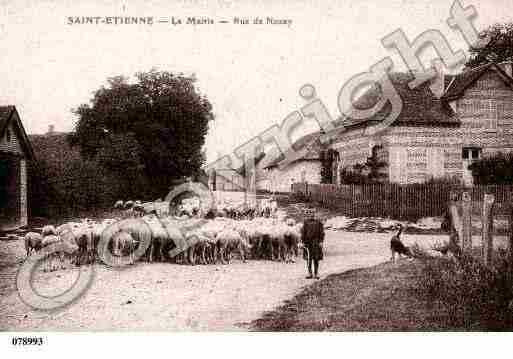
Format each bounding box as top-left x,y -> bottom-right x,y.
0,231 -> 504,331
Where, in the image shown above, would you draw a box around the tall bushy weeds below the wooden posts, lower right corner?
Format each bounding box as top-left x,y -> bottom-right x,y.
418,252 -> 513,330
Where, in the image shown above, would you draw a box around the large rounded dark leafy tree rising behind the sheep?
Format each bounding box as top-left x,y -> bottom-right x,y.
69,70 -> 213,197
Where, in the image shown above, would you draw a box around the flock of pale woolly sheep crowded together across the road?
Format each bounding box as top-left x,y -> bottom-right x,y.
25,198 -> 301,270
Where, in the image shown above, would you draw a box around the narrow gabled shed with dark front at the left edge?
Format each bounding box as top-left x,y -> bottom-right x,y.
0,106 -> 34,231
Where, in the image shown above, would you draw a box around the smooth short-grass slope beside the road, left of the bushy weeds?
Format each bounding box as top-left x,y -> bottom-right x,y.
251,260 -> 456,331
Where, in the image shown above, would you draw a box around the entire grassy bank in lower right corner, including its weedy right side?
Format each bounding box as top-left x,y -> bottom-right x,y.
250,258 -> 513,331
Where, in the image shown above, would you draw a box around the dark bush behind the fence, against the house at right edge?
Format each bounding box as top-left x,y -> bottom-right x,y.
469,153 -> 513,185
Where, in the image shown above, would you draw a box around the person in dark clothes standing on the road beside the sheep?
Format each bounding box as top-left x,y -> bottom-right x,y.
301,209 -> 324,279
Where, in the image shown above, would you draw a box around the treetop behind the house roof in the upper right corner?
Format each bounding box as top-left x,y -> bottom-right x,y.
466,23 -> 513,68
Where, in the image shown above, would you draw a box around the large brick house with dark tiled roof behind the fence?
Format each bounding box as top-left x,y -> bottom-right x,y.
324,62 -> 513,185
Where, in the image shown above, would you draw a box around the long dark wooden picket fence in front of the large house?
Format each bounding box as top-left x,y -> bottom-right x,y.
292,183 -> 513,220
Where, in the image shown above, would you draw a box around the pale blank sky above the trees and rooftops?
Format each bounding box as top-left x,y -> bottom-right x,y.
0,0 -> 513,162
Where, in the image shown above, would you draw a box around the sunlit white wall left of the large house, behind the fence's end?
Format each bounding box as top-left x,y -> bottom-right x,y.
257,160 -> 321,192
